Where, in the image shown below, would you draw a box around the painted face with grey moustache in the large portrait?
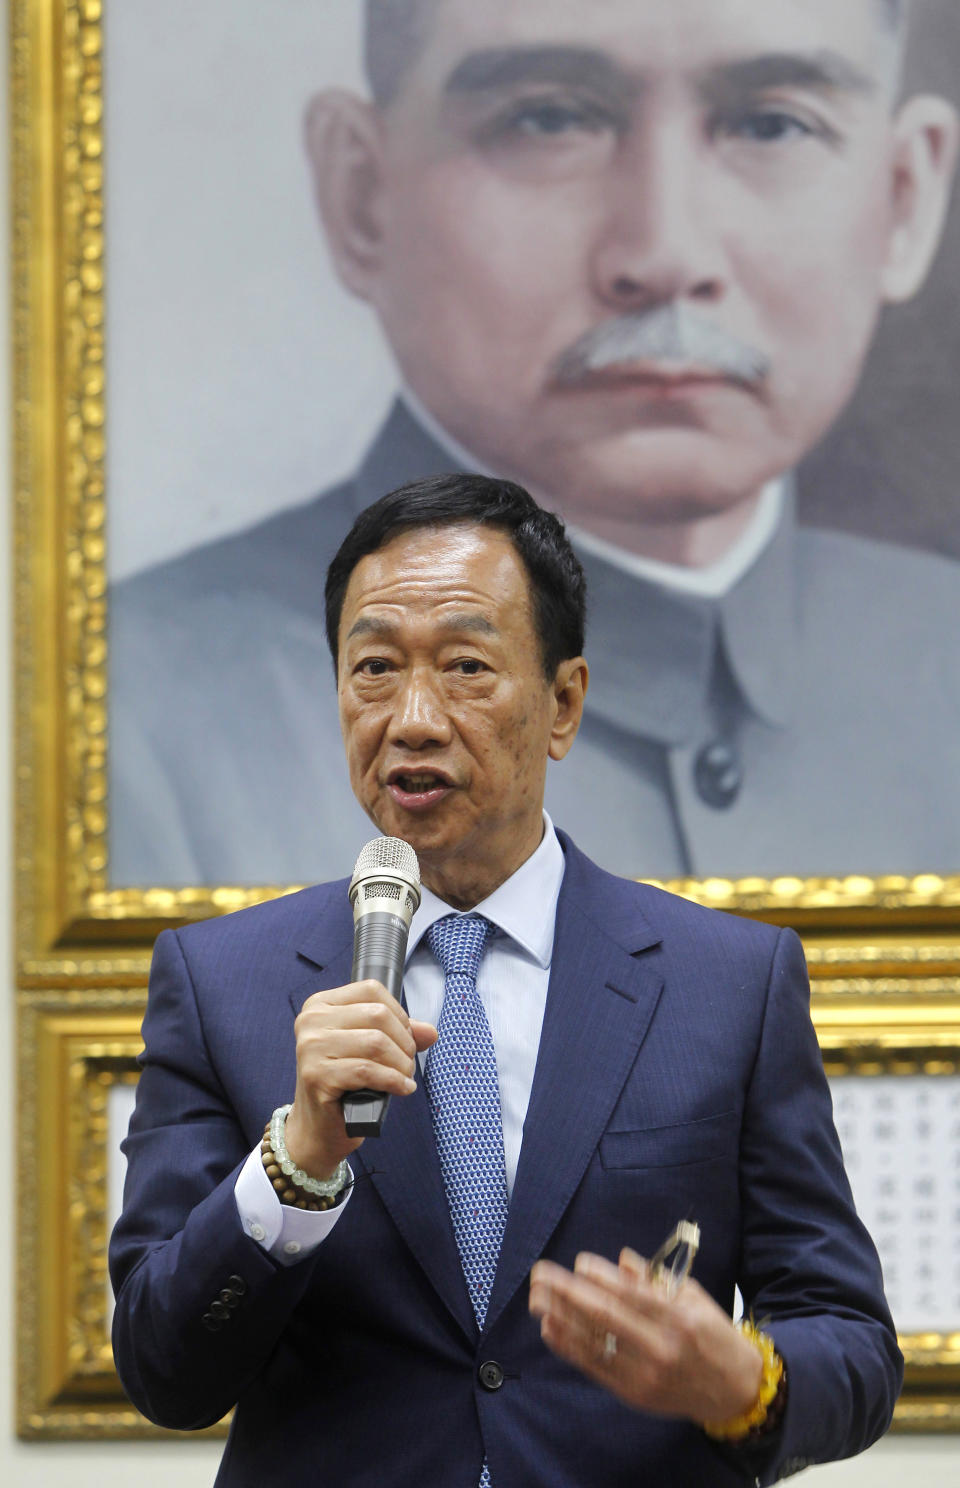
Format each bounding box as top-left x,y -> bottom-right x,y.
327,0 -> 934,542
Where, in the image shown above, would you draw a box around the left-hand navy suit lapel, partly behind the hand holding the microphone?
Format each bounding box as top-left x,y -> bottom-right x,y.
290,921 -> 476,1341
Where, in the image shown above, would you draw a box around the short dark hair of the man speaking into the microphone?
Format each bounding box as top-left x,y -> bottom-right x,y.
324,475 -> 586,682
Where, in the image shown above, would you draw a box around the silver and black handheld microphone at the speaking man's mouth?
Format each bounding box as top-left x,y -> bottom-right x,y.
341,838 -> 420,1137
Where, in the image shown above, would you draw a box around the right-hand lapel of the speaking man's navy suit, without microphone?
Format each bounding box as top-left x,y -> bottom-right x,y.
487,847 -> 662,1327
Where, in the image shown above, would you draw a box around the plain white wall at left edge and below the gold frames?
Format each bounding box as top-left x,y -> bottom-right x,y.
0,11 -> 960,1488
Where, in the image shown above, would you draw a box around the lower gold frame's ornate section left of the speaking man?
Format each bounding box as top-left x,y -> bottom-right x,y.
16,987 -> 225,1439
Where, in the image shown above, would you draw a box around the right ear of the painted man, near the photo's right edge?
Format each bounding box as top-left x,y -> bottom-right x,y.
881,95 -> 960,304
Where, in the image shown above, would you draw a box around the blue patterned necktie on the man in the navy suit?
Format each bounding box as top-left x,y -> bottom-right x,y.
424,915 -> 506,1488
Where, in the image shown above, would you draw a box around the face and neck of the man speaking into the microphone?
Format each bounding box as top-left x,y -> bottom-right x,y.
338,525 -> 582,906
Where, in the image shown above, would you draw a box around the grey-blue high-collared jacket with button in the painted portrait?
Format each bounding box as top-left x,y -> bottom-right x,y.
109,406 -> 960,884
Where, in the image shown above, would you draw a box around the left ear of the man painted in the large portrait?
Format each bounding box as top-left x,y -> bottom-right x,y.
304,88 -> 383,301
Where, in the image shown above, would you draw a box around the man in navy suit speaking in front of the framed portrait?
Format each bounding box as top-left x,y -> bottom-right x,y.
112,476 -> 902,1488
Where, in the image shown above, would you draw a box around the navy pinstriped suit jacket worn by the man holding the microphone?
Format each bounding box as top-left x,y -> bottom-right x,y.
110,838 -> 900,1488
